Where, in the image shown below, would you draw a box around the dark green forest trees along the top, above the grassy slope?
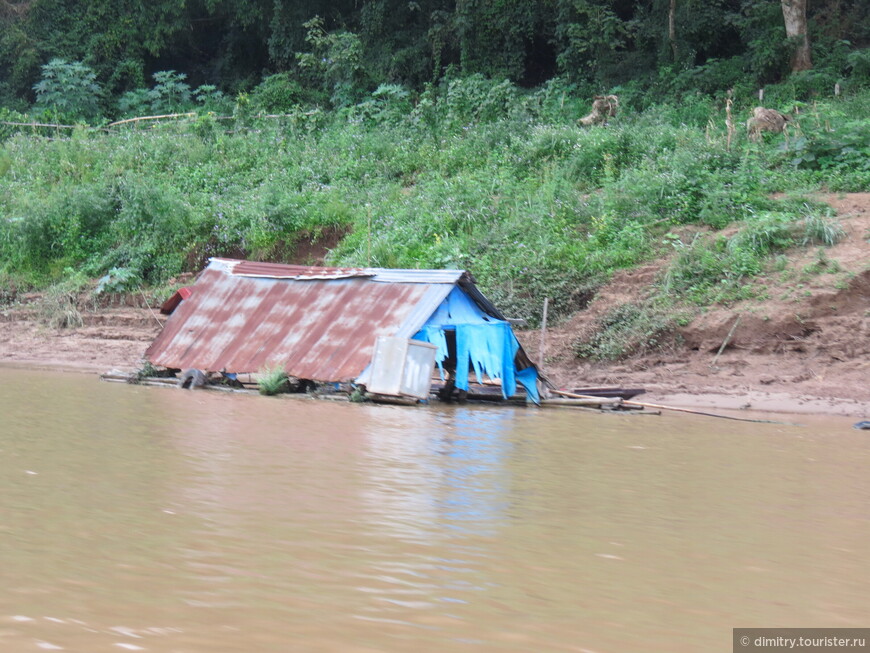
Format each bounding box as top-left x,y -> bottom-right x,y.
0,0 -> 870,120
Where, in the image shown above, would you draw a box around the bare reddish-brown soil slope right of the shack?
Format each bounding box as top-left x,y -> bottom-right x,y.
521,193 -> 870,415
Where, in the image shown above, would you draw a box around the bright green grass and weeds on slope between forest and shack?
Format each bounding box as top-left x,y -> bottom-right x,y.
0,78 -> 870,324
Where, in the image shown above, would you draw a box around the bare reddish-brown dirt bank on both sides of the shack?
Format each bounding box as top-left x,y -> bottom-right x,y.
0,194 -> 870,418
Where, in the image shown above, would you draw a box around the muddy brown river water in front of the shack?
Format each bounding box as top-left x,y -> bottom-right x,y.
0,368 -> 870,653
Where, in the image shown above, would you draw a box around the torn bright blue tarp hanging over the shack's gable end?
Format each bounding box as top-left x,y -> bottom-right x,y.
414,287 -> 539,403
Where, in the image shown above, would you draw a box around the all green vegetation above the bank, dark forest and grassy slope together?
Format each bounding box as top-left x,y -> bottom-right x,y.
0,0 -> 870,356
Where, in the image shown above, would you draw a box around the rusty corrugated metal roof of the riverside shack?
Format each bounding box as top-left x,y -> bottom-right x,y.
145,259 -> 460,381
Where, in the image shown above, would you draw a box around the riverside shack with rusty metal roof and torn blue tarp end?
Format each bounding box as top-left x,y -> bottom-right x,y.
145,258 -> 539,403
